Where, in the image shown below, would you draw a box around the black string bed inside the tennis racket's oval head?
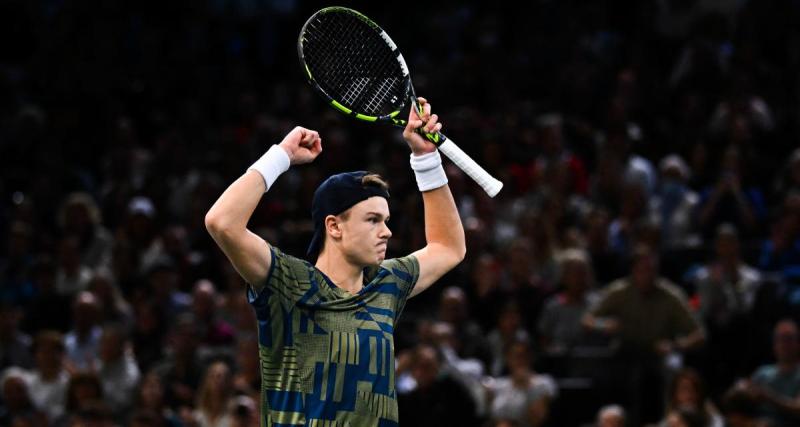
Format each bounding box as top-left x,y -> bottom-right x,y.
303,13 -> 406,116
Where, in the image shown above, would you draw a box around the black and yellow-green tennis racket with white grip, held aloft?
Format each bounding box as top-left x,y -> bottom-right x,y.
297,7 -> 503,197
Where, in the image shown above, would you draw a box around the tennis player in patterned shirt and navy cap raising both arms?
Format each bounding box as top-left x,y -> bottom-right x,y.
206,98 -> 466,427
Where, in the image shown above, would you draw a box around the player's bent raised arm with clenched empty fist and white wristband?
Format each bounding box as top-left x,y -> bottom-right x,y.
205,126 -> 322,284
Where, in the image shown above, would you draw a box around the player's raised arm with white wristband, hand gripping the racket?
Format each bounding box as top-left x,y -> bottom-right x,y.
403,98 -> 467,297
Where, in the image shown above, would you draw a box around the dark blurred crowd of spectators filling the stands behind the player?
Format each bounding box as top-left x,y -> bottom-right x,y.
0,0 -> 800,427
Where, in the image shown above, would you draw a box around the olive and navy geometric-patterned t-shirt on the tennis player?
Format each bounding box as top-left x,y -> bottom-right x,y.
248,247 -> 419,427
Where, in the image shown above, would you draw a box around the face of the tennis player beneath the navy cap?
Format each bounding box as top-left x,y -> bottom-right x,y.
328,196 -> 392,266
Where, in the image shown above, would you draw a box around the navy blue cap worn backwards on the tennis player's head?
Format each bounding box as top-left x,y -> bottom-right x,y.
306,171 -> 389,262
